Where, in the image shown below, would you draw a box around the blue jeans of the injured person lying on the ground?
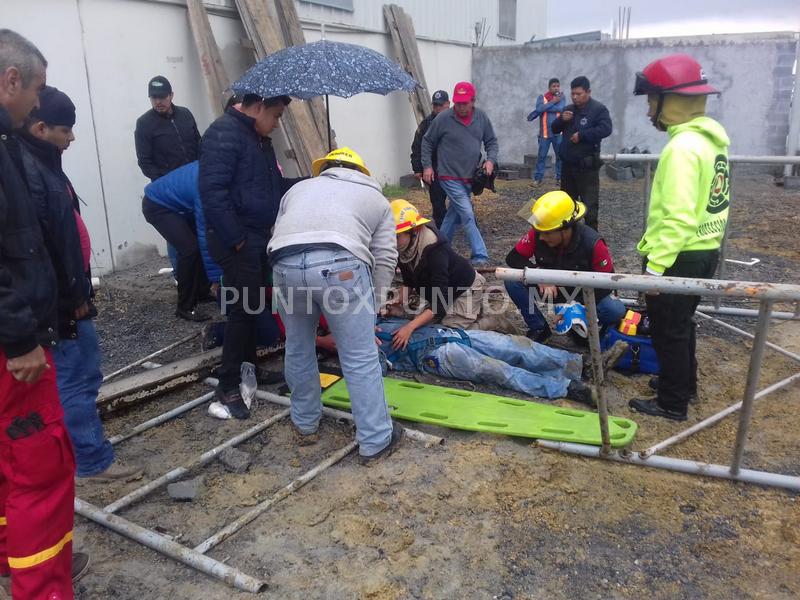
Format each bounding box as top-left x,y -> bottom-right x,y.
423,329 -> 583,399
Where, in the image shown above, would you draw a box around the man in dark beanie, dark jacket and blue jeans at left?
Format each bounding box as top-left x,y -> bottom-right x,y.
19,86 -> 141,483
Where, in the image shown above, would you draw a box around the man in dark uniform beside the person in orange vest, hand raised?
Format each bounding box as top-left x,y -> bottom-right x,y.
553,75 -> 611,230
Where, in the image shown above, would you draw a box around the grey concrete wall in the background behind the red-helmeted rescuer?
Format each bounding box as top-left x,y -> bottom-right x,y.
473,34 -> 797,162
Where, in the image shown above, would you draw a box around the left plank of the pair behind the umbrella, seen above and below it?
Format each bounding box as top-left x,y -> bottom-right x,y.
236,0 -> 327,175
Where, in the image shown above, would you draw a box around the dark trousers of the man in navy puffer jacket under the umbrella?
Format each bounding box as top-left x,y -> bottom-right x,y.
206,230 -> 270,394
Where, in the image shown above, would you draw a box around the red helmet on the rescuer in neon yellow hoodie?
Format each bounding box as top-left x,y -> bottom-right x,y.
633,54 -> 720,96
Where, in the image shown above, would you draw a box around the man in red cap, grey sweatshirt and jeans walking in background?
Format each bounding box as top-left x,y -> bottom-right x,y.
422,81 -> 498,267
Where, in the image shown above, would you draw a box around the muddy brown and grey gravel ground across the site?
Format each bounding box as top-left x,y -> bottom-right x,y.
76,171 -> 800,600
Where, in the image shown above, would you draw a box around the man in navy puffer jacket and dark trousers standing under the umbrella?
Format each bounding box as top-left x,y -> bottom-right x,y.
199,94 -> 298,419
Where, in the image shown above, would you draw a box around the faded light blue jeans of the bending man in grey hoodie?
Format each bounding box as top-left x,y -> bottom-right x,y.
273,249 -> 392,456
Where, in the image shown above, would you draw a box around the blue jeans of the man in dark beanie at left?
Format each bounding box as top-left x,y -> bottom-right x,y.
53,319 -> 114,477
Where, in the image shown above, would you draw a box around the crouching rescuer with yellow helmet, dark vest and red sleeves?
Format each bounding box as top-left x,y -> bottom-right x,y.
505,190 -> 625,343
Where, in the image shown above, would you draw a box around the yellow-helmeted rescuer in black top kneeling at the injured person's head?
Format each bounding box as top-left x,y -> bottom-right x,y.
390,199 -> 486,349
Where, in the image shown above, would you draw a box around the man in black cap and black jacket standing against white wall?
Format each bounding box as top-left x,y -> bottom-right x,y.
134,75 -> 200,181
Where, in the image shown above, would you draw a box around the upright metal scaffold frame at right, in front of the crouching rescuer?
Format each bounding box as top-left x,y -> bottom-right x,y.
496,268 -> 800,491
